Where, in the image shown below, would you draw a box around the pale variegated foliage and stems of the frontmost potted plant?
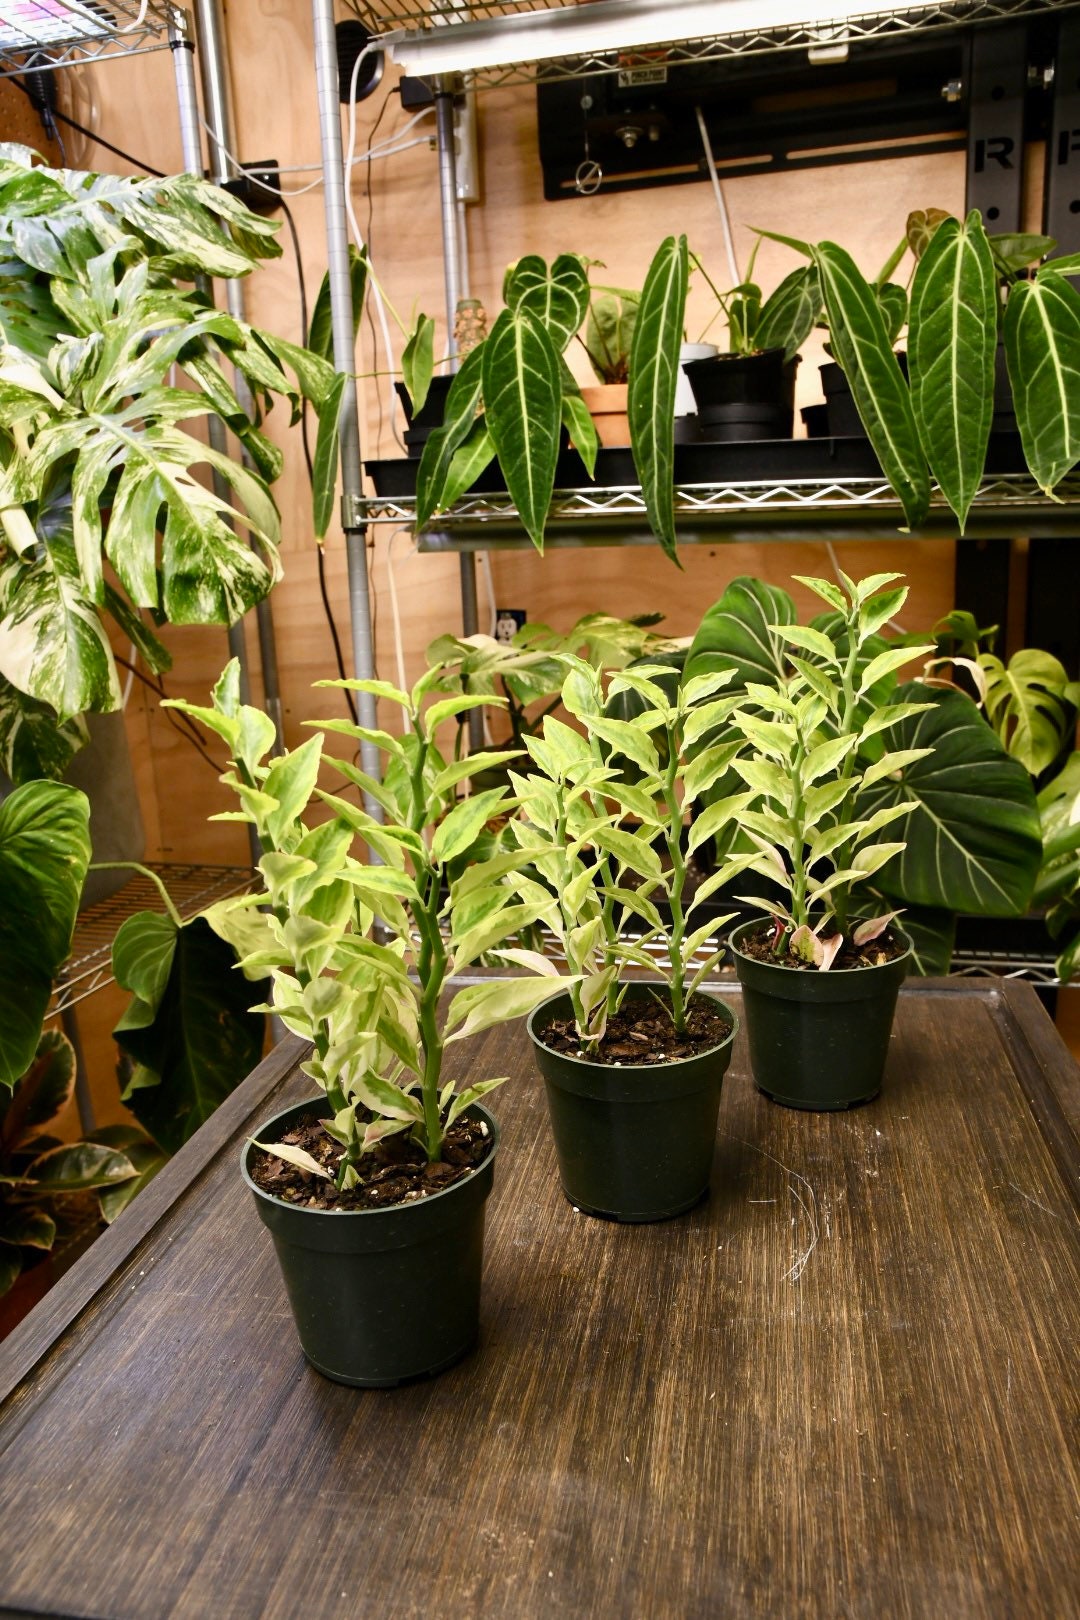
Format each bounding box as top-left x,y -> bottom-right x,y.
172,663 -> 565,1186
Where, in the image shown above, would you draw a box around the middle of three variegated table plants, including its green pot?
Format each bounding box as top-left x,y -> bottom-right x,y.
502,659 -> 750,1221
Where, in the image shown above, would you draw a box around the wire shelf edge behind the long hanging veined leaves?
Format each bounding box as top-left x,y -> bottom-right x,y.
358,473 -> 1080,551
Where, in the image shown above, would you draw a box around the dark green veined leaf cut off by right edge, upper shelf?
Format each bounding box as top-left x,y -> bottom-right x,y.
1006,272 -> 1080,494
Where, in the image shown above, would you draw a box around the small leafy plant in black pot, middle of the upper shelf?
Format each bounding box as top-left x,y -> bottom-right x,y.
683,238 -> 821,441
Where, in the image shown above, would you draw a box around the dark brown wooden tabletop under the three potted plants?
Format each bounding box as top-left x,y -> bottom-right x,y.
0,980 -> 1080,1620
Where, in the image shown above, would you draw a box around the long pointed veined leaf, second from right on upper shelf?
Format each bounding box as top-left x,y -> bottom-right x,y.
907,209 -> 997,533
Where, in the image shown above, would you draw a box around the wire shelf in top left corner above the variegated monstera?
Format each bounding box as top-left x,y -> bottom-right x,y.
0,0 -> 177,78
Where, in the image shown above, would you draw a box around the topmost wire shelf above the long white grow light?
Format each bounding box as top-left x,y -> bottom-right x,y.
341,0 -> 1075,87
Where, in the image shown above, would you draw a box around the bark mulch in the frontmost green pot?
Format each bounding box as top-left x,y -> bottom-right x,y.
251,1115 -> 491,1210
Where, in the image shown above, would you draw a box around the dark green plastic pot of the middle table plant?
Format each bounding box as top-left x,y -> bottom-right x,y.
528,985 -> 738,1221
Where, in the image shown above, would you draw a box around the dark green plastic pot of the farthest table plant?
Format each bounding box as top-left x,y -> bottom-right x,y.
729,917 -> 912,1111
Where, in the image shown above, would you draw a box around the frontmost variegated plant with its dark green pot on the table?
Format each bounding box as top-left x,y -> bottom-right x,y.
175,651 -> 557,1385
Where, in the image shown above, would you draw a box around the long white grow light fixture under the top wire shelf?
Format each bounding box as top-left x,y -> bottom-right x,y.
382,0 -> 1054,78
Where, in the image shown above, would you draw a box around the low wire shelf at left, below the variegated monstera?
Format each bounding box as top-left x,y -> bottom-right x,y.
49,862 -> 254,1017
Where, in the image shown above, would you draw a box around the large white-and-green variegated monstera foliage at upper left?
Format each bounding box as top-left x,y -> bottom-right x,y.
0,146 -> 334,781
